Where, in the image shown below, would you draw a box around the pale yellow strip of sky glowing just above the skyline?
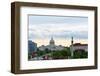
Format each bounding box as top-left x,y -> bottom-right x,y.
29,39 -> 88,47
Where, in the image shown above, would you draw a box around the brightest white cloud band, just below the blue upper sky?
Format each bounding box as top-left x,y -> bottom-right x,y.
29,24 -> 88,32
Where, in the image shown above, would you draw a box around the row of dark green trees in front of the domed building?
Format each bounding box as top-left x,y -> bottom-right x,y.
37,47 -> 88,59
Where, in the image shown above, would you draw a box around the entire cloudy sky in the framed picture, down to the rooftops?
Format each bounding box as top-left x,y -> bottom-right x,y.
28,15 -> 88,46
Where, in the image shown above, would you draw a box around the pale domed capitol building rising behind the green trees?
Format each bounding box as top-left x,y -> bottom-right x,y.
39,37 -> 64,51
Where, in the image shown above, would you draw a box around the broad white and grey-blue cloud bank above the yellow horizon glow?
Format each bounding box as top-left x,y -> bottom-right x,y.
29,23 -> 88,39
